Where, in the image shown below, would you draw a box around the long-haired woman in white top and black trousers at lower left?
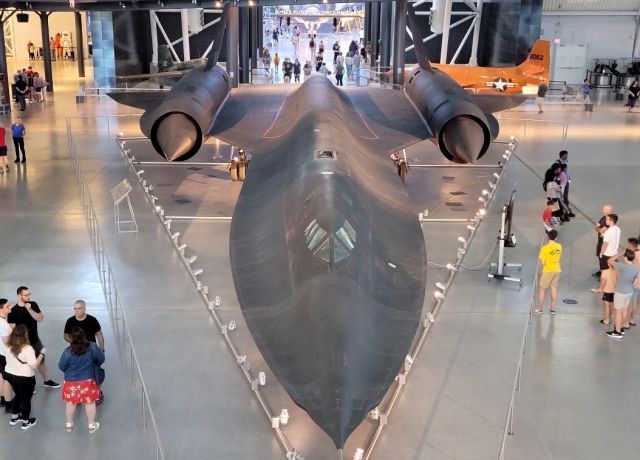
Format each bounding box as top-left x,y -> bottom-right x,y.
5,324 -> 47,430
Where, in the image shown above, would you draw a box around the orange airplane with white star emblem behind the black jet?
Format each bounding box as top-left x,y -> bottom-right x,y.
431,40 -> 551,94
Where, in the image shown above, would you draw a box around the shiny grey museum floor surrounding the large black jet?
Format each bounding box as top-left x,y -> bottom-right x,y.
0,58 -> 640,460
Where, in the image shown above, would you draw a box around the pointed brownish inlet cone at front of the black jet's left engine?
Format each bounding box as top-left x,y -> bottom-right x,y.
156,113 -> 198,161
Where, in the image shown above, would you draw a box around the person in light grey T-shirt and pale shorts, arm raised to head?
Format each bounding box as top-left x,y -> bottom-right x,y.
607,249 -> 638,339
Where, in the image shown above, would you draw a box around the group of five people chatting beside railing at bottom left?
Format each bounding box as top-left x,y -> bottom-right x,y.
0,286 -> 105,433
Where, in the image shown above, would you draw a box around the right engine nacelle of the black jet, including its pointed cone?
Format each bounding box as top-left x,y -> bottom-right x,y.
405,68 -> 492,163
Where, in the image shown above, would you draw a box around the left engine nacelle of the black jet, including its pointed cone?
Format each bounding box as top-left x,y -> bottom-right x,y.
140,66 -> 231,161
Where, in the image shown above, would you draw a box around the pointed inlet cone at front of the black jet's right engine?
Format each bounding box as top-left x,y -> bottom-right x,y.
442,117 -> 485,163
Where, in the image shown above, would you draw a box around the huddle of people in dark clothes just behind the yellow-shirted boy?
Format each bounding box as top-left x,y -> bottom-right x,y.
542,150 -> 575,231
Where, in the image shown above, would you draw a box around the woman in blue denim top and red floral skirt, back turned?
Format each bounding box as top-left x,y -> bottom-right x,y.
58,328 -> 104,433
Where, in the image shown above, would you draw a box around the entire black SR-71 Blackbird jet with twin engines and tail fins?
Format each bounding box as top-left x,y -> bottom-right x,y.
112,1 -> 523,450
